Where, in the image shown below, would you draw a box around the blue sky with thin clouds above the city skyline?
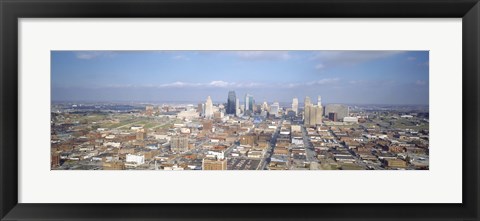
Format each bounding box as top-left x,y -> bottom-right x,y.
51,51 -> 429,104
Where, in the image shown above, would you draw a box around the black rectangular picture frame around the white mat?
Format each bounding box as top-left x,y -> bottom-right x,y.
0,0 -> 480,221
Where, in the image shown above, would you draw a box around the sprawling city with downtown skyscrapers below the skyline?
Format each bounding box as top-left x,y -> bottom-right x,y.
51,91 -> 429,170
